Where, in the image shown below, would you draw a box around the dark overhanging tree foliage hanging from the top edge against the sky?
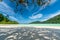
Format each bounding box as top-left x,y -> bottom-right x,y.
10,0 -> 46,14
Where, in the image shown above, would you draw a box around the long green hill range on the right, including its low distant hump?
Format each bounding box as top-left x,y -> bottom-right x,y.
31,15 -> 60,24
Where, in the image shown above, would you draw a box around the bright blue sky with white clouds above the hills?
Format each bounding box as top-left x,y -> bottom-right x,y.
0,0 -> 60,23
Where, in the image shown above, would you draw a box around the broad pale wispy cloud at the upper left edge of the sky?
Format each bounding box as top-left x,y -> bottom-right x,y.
0,2 -> 15,14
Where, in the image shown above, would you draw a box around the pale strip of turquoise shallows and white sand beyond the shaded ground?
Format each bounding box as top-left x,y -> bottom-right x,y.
0,24 -> 60,29
